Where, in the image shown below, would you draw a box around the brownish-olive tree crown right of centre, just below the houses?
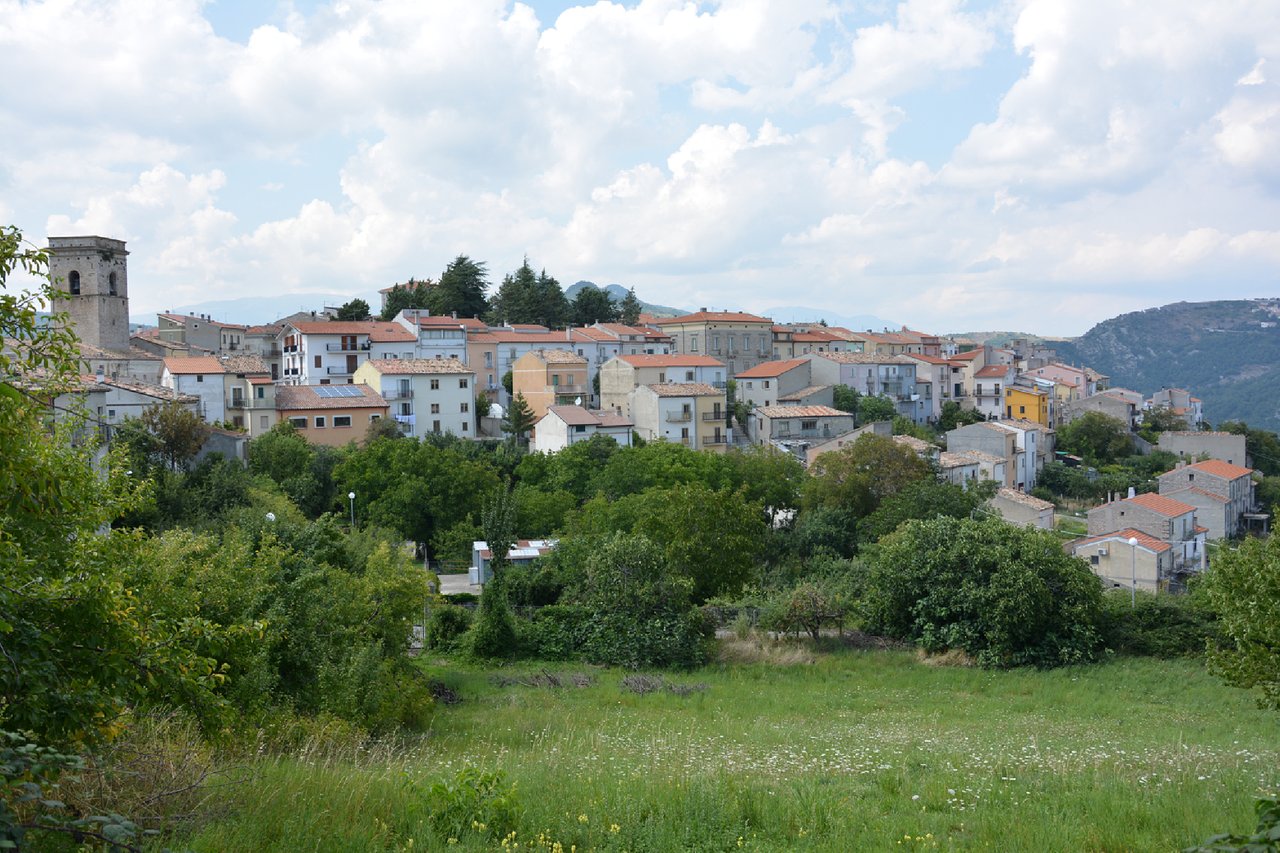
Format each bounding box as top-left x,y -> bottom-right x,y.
804,433 -> 933,519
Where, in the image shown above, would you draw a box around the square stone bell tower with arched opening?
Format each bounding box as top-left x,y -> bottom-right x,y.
49,237 -> 129,353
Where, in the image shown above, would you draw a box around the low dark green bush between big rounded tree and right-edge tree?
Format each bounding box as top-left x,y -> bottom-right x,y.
1102,589 -> 1219,658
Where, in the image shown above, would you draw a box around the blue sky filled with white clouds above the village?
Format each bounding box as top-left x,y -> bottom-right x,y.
0,0 -> 1280,336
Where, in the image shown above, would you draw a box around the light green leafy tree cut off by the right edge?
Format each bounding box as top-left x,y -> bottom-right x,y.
1199,535 -> 1280,708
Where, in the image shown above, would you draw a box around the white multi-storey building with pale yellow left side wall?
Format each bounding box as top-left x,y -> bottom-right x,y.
352,357 -> 476,438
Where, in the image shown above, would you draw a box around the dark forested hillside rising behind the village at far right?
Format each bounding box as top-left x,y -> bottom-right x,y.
1055,298 -> 1280,430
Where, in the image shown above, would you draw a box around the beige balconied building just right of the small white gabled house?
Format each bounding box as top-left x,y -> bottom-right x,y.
631,382 -> 728,450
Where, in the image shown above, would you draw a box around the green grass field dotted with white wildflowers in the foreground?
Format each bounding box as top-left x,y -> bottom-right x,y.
183,651 -> 1280,852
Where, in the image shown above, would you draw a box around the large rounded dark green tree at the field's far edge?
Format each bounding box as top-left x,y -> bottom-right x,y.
865,517 -> 1102,667
